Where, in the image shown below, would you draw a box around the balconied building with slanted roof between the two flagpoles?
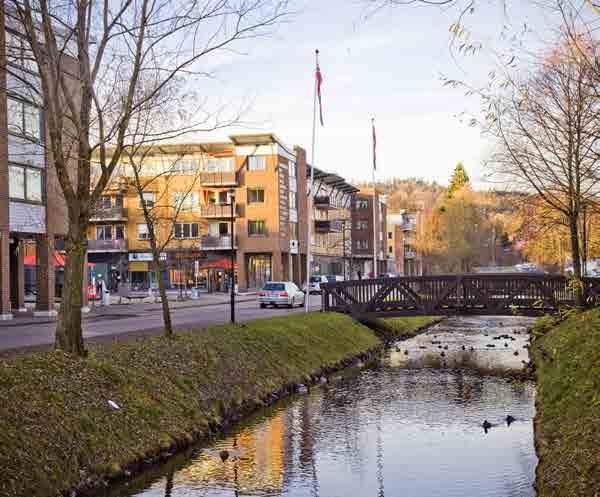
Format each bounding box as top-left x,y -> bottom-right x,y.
308,167 -> 359,277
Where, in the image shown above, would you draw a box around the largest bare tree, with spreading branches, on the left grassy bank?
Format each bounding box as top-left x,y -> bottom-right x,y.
6,0 -> 287,355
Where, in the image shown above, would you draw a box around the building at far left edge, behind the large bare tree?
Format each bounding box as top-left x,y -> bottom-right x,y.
0,6 -> 77,319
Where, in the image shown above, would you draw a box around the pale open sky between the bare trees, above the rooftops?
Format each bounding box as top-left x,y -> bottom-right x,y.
191,0 -> 568,188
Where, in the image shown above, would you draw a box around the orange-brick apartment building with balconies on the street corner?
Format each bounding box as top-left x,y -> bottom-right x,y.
88,134 -> 314,291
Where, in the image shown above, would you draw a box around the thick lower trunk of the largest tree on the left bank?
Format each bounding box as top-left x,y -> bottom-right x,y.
54,226 -> 87,356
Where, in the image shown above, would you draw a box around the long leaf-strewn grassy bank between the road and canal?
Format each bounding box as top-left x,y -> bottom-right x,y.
0,313 -> 436,497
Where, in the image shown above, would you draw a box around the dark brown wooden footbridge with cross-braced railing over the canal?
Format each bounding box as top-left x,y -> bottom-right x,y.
321,273 -> 600,318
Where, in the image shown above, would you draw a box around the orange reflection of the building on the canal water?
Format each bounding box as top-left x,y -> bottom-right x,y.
175,406 -> 286,492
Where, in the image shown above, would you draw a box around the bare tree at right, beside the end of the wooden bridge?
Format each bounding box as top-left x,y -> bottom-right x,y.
484,34 -> 600,304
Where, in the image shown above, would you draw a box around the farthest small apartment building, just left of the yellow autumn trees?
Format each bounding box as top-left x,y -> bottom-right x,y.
387,211 -> 423,276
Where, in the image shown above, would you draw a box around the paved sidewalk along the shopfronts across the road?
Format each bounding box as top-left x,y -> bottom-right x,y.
0,292 -> 256,329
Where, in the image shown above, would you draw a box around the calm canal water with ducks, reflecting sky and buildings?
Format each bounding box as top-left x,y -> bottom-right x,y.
102,317 -> 537,497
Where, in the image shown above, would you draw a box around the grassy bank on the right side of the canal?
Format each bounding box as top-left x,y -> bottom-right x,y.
531,310 -> 600,497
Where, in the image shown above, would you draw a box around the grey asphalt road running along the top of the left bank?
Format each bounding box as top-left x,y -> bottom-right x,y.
0,295 -> 321,355
